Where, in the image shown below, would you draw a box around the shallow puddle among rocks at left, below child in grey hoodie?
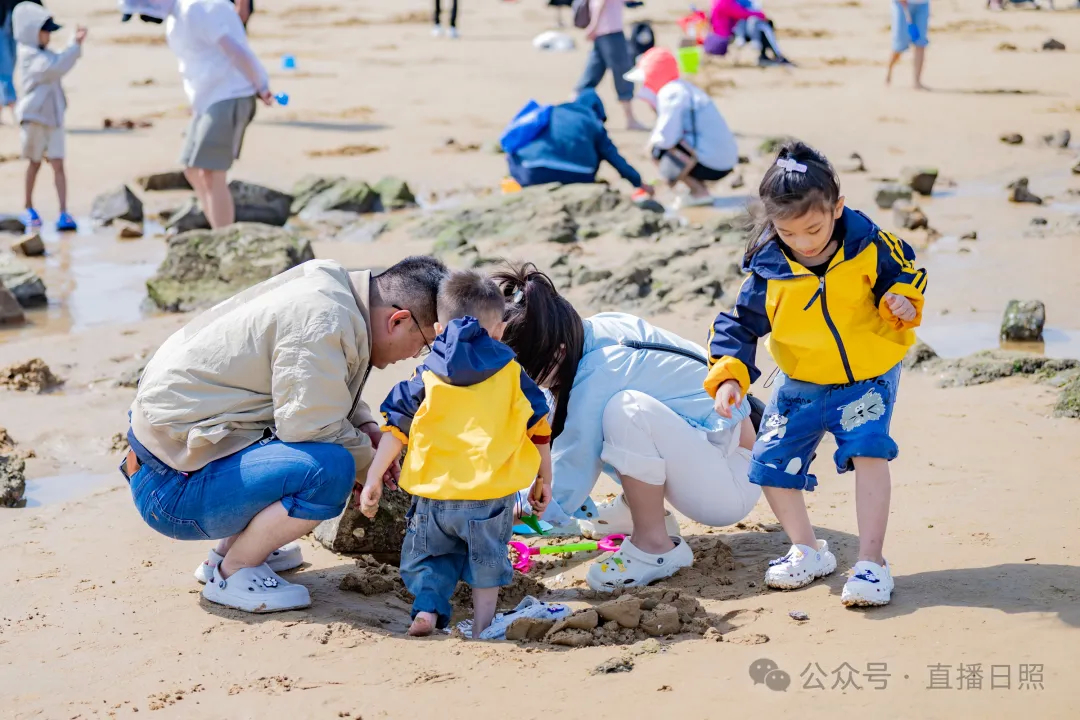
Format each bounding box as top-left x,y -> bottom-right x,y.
0,218 -> 165,342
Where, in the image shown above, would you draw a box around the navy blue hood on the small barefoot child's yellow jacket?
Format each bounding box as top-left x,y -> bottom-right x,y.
424,317 -> 514,385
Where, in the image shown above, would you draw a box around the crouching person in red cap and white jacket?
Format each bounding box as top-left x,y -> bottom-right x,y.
626,47 -> 739,206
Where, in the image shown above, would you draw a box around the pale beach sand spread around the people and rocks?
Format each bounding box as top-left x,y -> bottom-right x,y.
0,0 -> 1080,719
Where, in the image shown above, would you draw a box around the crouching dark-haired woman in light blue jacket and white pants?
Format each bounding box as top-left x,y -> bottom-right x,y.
496,264 -> 760,592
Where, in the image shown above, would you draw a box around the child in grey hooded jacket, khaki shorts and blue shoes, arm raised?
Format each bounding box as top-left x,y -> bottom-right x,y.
12,2 -> 86,232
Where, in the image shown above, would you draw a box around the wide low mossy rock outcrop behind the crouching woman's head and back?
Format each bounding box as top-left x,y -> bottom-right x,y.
413,185 -> 750,313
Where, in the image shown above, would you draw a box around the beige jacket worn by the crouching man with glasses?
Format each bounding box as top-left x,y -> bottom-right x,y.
132,260 -> 374,474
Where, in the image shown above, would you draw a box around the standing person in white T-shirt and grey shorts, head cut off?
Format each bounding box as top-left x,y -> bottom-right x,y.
120,0 -> 273,228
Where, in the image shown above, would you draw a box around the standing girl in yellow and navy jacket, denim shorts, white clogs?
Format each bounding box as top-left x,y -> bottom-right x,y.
705,141 -> 927,607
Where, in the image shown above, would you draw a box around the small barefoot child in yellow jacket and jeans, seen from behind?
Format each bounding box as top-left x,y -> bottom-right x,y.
361,271 -> 551,638
